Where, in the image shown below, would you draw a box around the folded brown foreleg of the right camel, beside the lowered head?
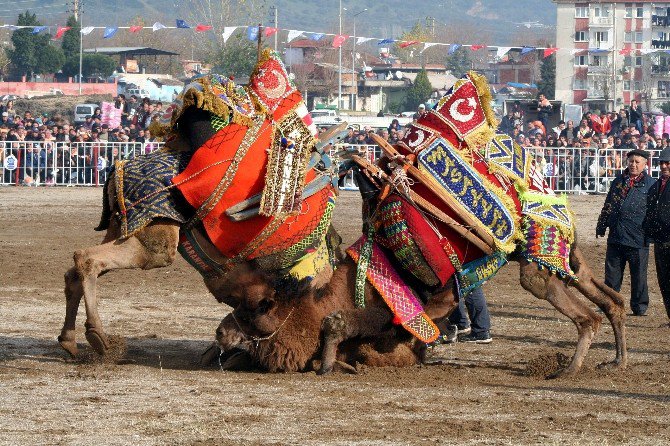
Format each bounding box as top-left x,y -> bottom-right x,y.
317,307 -> 393,375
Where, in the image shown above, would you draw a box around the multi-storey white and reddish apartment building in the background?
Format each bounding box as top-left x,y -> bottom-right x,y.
554,0 -> 670,110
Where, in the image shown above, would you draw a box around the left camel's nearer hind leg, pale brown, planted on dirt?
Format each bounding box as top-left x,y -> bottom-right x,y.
64,223 -> 179,355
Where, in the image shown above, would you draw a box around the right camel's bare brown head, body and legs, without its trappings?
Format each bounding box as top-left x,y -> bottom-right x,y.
217,166 -> 627,378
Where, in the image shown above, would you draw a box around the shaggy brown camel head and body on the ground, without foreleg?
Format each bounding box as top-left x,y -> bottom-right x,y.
216,258 -> 436,372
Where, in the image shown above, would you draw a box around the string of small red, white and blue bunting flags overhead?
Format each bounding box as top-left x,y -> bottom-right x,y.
0,19 -> 670,59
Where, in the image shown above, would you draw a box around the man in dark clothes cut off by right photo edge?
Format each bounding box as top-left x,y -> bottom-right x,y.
644,148 -> 670,324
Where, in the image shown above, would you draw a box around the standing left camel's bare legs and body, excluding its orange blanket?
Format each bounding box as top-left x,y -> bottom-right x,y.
58,98 -> 346,356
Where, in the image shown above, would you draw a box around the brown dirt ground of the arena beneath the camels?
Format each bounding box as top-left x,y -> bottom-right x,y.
0,187 -> 670,445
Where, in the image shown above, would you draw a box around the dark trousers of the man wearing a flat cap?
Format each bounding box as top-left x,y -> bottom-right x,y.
605,243 -> 649,315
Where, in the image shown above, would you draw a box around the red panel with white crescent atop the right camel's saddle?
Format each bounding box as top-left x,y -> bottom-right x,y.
434,77 -> 486,139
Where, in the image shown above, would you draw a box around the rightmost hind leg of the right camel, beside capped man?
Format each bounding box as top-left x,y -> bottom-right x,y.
569,246 -> 628,368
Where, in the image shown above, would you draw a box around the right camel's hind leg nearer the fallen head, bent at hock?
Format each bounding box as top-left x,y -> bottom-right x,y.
521,260 -> 602,378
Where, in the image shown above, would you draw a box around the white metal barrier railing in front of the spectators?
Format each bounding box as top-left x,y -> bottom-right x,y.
0,141 -> 659,193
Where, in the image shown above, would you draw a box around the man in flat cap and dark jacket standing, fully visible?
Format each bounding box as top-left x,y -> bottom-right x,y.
596,149 -> 654,316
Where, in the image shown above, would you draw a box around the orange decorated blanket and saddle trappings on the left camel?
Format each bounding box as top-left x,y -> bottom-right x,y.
114,50 -> 336,278
